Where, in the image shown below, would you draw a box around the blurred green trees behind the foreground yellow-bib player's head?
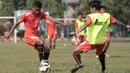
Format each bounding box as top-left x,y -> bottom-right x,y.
75,0 -> 130,24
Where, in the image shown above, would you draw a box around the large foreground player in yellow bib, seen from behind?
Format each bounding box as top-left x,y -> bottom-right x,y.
71,1 -> 129,73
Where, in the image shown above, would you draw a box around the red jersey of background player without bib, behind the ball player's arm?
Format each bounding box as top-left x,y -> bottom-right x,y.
46,21 -> 56,34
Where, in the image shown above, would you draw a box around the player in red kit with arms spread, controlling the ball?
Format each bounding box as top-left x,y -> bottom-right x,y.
5,1 -> 65,71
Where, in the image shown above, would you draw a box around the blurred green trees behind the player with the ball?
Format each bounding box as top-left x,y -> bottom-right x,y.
0,0 -> 65,32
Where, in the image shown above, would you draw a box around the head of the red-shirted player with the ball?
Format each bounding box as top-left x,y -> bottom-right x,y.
32,1 -> 42,16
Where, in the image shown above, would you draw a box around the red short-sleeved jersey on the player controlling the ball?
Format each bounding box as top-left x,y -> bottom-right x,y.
18,10 -> 47,38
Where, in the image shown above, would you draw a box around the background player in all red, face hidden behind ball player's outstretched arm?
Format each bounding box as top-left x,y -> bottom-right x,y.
46,15 -> 57,51
